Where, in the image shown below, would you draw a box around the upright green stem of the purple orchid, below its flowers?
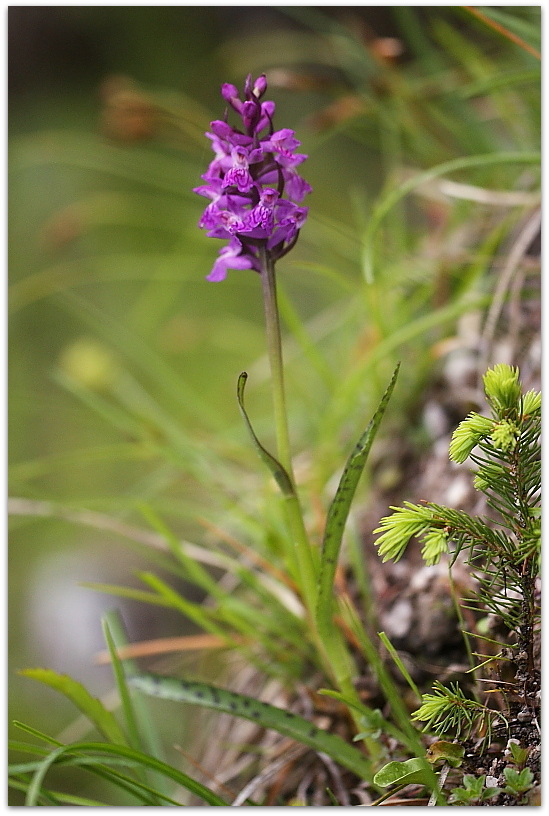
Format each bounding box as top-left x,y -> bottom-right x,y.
259,247 -> 317,618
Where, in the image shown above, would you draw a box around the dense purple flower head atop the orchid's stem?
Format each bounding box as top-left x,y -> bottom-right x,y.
194,74 -> 311,281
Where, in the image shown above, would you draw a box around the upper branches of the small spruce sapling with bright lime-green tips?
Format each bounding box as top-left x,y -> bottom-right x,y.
375,364 -> 541,632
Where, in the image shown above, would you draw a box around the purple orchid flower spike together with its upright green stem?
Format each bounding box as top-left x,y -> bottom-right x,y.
194,74 -> 317,613
